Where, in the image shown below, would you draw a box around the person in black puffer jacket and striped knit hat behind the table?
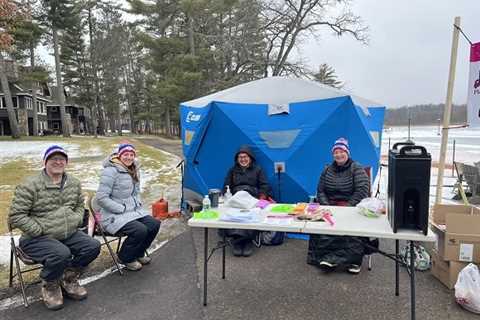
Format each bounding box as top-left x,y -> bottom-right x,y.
307,138 -> 370,274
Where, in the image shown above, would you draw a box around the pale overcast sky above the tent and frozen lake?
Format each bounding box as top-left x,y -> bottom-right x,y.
302,0 -> 480,108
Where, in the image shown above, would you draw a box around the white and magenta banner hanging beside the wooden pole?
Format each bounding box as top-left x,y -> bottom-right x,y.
467,42 -> 480,127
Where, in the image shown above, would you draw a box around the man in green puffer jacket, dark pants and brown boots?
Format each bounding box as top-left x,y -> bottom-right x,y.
9,145 -> 100,310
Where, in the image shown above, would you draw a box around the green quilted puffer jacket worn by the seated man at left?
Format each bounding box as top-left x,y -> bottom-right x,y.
9,170 -> 84,240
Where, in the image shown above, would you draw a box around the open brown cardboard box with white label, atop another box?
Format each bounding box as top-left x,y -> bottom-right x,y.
431,204 -> 480,263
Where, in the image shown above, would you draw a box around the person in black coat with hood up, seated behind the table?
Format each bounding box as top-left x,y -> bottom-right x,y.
223,146 -> 271,257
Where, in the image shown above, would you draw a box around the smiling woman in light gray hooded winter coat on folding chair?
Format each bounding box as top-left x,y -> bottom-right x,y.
96,143 -> 160,271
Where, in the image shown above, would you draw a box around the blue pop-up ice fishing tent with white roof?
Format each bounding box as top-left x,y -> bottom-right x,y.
180,77 -> 385,203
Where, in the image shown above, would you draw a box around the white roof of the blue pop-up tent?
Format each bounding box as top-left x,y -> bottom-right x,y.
182,77 -> 383,114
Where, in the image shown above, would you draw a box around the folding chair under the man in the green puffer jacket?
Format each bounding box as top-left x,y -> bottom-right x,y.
8,223 -> 42,307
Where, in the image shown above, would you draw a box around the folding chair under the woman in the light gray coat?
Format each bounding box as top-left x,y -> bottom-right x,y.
87,195 -> 123,275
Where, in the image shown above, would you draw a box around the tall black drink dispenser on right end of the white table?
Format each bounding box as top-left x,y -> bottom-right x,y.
387,142 -> 432,235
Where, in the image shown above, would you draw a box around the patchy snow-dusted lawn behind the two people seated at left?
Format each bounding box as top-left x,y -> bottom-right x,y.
0,136 -> 181,288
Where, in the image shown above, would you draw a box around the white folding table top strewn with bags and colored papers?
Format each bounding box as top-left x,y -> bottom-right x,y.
188,206 -> 436,242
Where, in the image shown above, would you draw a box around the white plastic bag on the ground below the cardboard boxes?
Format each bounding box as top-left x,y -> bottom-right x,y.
455,263 -> 480,314
